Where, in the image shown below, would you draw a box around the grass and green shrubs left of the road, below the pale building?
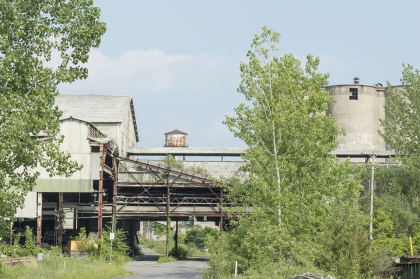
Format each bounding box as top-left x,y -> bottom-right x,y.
0,225 -> 130,279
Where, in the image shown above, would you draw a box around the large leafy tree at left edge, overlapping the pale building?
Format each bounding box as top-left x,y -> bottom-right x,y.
0,0 -> 106,235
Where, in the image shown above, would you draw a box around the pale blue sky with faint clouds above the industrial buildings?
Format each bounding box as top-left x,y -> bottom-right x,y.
60,0 -> 420,150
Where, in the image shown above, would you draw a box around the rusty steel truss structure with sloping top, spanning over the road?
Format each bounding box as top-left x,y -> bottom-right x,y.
114,157 -> 226,224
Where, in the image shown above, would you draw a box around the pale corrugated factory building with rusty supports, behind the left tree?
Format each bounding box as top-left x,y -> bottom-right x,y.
14,95 -> 138,246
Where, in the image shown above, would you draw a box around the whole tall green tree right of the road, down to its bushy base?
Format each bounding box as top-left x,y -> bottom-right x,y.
205,27 -> 361,278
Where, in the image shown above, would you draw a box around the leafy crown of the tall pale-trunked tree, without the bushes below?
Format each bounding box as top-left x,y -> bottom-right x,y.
225,27 -> 355,232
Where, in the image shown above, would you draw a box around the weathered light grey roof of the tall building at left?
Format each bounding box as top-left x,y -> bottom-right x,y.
55,94 -> 139,141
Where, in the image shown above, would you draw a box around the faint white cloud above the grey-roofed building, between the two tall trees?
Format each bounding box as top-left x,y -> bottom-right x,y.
61,49 -> 236,95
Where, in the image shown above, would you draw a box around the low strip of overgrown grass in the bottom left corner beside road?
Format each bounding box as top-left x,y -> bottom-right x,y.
0,257 -> 131,279
